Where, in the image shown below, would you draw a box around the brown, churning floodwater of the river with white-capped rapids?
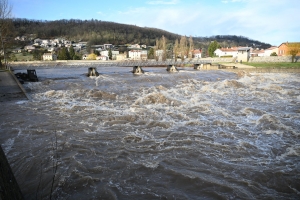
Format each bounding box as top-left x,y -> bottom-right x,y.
0,67 -> 300,199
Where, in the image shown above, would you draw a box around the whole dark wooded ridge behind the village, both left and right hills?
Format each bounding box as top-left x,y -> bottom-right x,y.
13,19 -> 271,48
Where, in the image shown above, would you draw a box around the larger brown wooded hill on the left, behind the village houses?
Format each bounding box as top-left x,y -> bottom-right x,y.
13,19 -> 180,45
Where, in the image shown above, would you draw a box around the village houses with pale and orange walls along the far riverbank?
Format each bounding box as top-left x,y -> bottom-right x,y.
15,36 -> 300,62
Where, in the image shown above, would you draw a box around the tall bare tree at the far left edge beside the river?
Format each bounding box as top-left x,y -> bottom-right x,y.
0,0 -> 12,68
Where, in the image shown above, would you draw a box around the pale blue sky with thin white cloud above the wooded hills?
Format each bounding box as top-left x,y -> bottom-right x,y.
8,0 -> 300,46
